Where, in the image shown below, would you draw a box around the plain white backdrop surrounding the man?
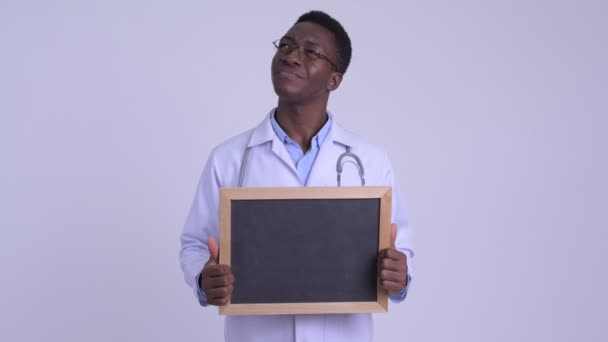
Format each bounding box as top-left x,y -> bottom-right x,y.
0,0 -> 608,342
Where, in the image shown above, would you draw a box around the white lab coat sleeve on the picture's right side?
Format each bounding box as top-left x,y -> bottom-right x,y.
385,154 -> 414,302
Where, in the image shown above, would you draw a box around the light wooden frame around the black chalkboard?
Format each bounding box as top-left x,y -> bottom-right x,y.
219,186 -> 392,315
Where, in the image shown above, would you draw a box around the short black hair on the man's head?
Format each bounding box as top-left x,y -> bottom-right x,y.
296,11 -> 352,74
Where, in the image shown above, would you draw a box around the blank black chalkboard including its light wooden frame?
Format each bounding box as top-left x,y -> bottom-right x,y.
220,187 -> 391,315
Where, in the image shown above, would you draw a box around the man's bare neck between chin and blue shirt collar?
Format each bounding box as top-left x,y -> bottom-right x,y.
276,99 -> 327,152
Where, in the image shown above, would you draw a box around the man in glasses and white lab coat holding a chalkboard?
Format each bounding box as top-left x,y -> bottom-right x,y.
180,11 -> 413,342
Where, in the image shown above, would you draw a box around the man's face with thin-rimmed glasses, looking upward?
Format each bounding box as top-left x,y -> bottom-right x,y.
271,22 -> 342,103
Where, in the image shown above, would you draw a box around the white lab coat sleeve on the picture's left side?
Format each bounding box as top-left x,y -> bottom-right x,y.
179,152 -> 220,306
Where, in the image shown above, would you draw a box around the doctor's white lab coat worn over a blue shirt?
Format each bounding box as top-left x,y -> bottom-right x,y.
180,109 -> 413,342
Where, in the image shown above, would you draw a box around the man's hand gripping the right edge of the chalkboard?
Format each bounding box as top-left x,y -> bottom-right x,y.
378,224 -> 407,295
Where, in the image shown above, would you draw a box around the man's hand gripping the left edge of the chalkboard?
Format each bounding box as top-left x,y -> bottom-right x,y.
199,237 -> 234,305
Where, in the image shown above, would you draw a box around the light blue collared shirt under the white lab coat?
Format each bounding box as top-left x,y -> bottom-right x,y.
270,114 -> 331,185
